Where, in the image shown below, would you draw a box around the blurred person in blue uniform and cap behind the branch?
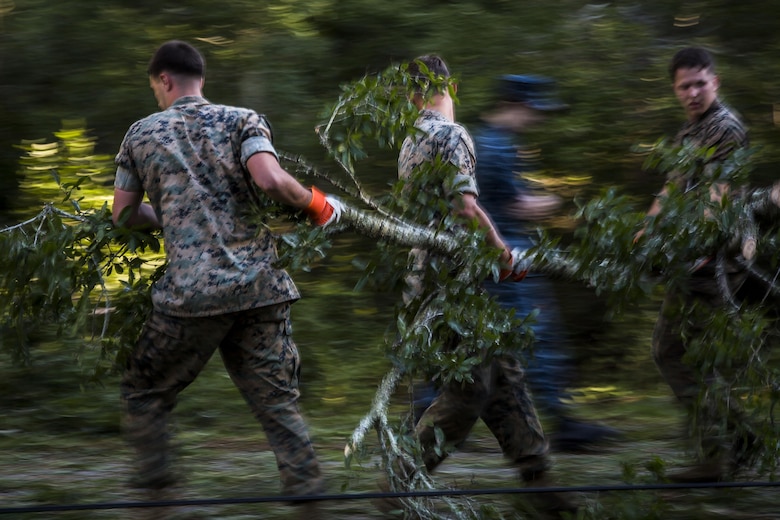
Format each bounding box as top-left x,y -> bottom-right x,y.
474,75 -> 617,450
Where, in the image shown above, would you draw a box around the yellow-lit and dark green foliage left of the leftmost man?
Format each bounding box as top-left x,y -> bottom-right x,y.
0,125 -> 163,378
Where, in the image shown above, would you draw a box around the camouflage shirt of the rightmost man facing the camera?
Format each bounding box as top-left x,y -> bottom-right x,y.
670,101 -> 748,187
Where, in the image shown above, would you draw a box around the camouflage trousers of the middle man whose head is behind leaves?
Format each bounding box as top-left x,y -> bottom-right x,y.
415,356 -> 549,480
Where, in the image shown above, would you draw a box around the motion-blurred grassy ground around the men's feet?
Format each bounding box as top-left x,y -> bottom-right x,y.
0,397 -> 780,520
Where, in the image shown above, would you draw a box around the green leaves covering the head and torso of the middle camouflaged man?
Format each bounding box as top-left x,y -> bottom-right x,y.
318,64 -> 525,390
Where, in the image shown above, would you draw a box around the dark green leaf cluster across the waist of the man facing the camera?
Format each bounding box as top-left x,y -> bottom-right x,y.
564,140 -> 753,311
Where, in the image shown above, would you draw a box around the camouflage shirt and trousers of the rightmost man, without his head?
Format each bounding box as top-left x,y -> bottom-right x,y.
652,102 -> 748,458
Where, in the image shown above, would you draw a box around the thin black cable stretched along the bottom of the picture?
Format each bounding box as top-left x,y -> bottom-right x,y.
0,481 -> 780,515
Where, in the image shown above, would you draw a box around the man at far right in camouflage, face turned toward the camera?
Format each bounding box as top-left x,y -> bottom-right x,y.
651,48 -> 749,482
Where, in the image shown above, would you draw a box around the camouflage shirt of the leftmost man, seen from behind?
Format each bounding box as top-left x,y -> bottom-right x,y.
114,96 -> 299,317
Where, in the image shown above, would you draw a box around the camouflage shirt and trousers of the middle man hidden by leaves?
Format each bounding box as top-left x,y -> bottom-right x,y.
398,110 -> 549,479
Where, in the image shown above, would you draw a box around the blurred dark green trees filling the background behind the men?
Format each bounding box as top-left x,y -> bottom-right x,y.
0,0 -> 780,516
